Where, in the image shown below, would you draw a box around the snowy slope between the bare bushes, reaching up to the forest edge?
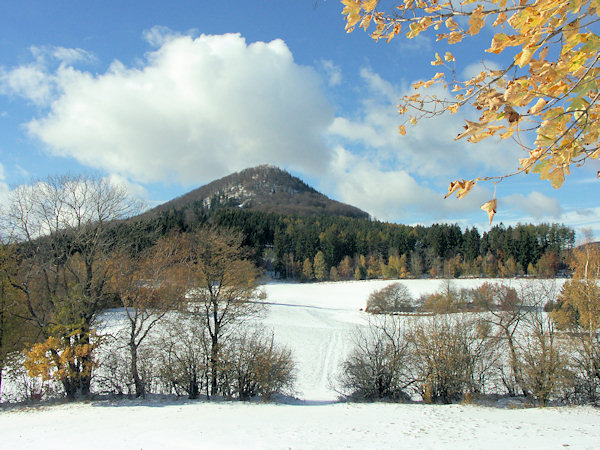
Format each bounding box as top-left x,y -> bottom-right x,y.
263,279 -> 564,402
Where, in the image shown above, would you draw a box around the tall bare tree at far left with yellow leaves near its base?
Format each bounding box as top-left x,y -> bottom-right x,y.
7,176 -> 137,398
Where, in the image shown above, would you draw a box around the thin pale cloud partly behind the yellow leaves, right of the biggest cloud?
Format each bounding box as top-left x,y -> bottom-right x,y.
329,69 -> 521,184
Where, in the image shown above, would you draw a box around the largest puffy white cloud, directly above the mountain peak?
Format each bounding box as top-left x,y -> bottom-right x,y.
8,33 -> 333,184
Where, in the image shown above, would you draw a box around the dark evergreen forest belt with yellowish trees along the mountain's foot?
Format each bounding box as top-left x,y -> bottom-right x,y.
119,207 -> 575,281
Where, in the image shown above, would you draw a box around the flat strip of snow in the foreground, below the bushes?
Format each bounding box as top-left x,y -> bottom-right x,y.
0,401 -> 600,450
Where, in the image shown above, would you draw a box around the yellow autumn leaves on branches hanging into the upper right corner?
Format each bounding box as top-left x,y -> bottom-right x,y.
342,0 -> 600,224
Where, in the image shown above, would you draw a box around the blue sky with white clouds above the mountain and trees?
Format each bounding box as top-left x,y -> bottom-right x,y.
0,0 -> 600,237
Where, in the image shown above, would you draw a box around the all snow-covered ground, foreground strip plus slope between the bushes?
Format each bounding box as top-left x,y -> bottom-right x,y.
0,280 -> 600,449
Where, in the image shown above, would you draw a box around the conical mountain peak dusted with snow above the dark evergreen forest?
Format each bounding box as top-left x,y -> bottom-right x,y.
143,165 -> 369,219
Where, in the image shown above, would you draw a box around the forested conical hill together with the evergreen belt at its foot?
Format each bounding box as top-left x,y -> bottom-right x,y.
114,166 -> 575,280
